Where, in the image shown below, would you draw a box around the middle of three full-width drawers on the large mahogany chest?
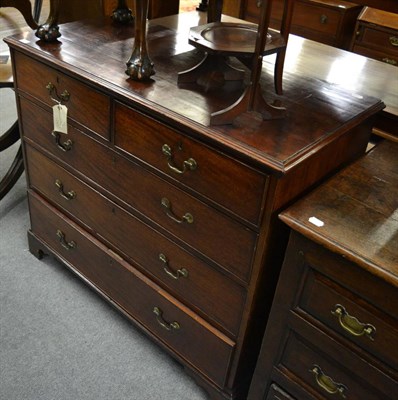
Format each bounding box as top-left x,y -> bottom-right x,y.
26,146 -> 245,336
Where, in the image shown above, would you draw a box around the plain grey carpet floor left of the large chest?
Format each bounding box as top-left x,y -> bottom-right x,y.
0,90 -> 208,400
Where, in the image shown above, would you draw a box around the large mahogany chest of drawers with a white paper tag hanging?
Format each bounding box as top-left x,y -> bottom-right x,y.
7,15 -> 383,399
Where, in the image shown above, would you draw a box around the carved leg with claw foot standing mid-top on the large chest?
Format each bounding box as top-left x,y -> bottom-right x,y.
126,0 -> 155,81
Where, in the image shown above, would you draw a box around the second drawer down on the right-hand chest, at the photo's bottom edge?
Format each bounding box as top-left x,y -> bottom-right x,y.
276,330 -> 394,400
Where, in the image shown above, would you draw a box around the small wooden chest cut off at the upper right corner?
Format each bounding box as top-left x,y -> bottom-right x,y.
351,7 -> 398,66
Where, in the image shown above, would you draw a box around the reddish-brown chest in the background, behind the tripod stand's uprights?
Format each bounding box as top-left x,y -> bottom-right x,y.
244,0 -> 362,49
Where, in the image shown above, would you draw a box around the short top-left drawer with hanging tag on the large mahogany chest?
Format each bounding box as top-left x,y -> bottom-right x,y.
15,53 -> 110,139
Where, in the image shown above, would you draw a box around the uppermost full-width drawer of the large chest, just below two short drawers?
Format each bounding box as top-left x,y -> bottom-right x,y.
20,98 -> 257,281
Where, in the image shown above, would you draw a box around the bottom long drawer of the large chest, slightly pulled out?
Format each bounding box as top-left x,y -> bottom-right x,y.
29,193 -> 234,386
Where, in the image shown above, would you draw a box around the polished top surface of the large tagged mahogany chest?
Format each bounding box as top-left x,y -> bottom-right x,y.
7,13 -> 384,173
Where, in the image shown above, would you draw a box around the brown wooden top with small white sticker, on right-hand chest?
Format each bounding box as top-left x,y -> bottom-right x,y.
280,141 -> 398,287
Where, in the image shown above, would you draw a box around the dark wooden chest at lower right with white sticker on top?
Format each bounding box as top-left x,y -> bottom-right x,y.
249,142 -> 398,400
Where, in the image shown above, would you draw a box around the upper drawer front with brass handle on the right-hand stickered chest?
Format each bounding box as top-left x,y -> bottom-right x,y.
298,259 -> 398,368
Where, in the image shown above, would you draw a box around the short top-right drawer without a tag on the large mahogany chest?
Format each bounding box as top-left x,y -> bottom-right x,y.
115,103 -> 267,225
